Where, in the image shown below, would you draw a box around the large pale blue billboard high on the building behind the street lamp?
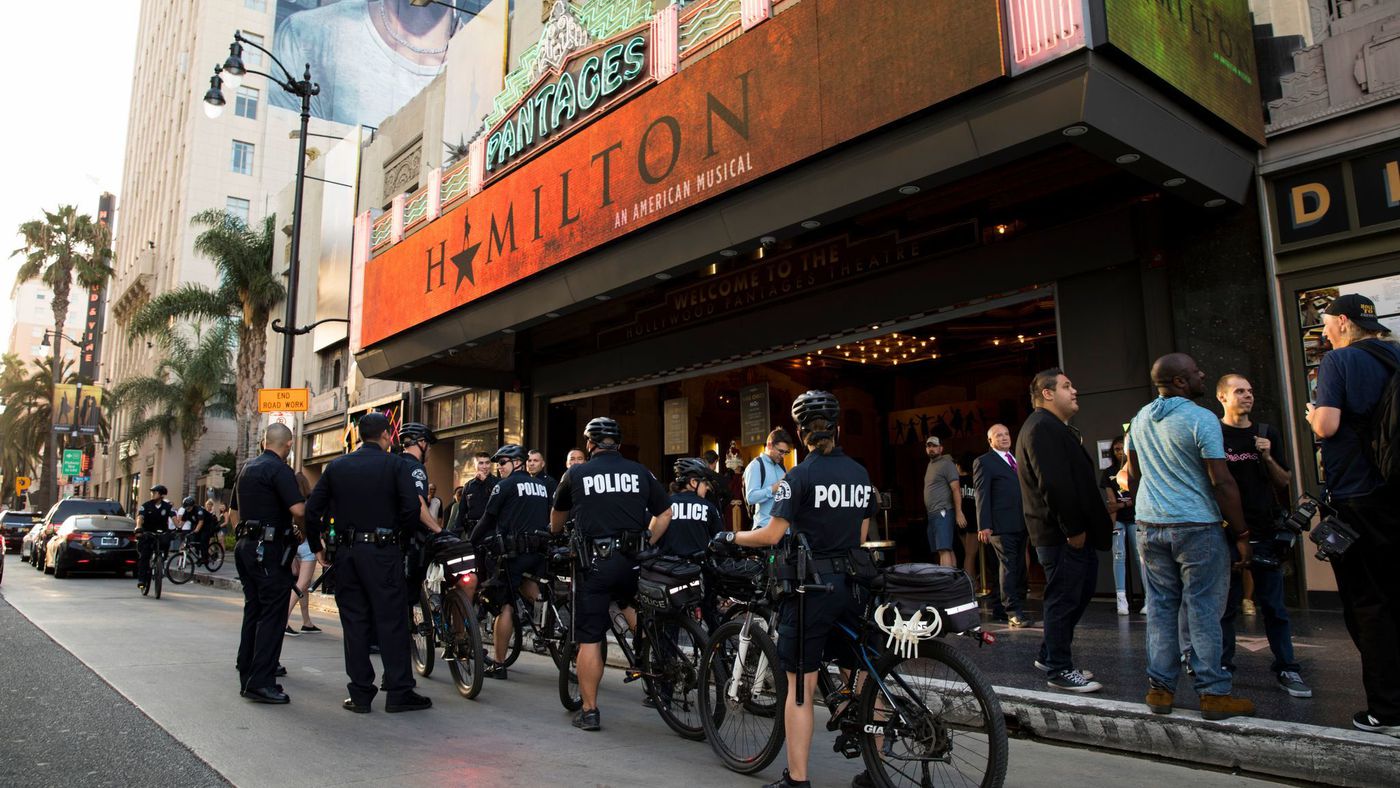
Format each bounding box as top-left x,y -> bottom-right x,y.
273,0 -> 487,126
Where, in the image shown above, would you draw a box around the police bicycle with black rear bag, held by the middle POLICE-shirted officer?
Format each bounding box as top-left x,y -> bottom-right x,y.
559,547 -> 706,740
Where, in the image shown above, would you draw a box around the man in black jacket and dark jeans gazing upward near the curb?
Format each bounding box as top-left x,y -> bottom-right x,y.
1016,368 -> 1113,693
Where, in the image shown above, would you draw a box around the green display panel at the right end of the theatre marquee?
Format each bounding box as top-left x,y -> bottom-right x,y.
1103,0 -> 1264,144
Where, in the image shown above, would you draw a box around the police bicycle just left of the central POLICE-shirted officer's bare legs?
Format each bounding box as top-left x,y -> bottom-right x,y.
476,532 -> 574,668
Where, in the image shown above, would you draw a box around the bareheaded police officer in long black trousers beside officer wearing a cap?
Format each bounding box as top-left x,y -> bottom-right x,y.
228,424 -> 309,703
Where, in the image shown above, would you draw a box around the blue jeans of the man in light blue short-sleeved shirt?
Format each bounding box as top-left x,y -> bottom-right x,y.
1137,522 -> 1231,696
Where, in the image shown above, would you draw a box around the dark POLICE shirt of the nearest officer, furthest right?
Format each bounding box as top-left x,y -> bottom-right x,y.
773,448 -> 879,558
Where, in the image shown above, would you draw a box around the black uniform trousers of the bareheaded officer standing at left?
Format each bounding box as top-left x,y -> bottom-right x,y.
234,536 -> 295,690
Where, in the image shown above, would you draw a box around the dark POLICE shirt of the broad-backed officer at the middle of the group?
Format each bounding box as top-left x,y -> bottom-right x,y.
554,451 -> 666,539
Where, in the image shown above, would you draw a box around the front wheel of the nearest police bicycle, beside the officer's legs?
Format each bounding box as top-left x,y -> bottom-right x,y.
700,620 -> 787,774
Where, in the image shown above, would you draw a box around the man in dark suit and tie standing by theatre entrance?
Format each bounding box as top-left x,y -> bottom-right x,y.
972,424 -> 1035,628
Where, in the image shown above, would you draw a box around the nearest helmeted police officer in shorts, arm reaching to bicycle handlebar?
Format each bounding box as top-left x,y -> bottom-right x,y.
715,391 -> 876,788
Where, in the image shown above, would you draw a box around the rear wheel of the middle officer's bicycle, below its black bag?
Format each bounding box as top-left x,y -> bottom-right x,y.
637,616 -> 706,742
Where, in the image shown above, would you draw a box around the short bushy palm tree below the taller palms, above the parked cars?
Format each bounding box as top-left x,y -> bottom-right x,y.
111,319 -> 238,491
